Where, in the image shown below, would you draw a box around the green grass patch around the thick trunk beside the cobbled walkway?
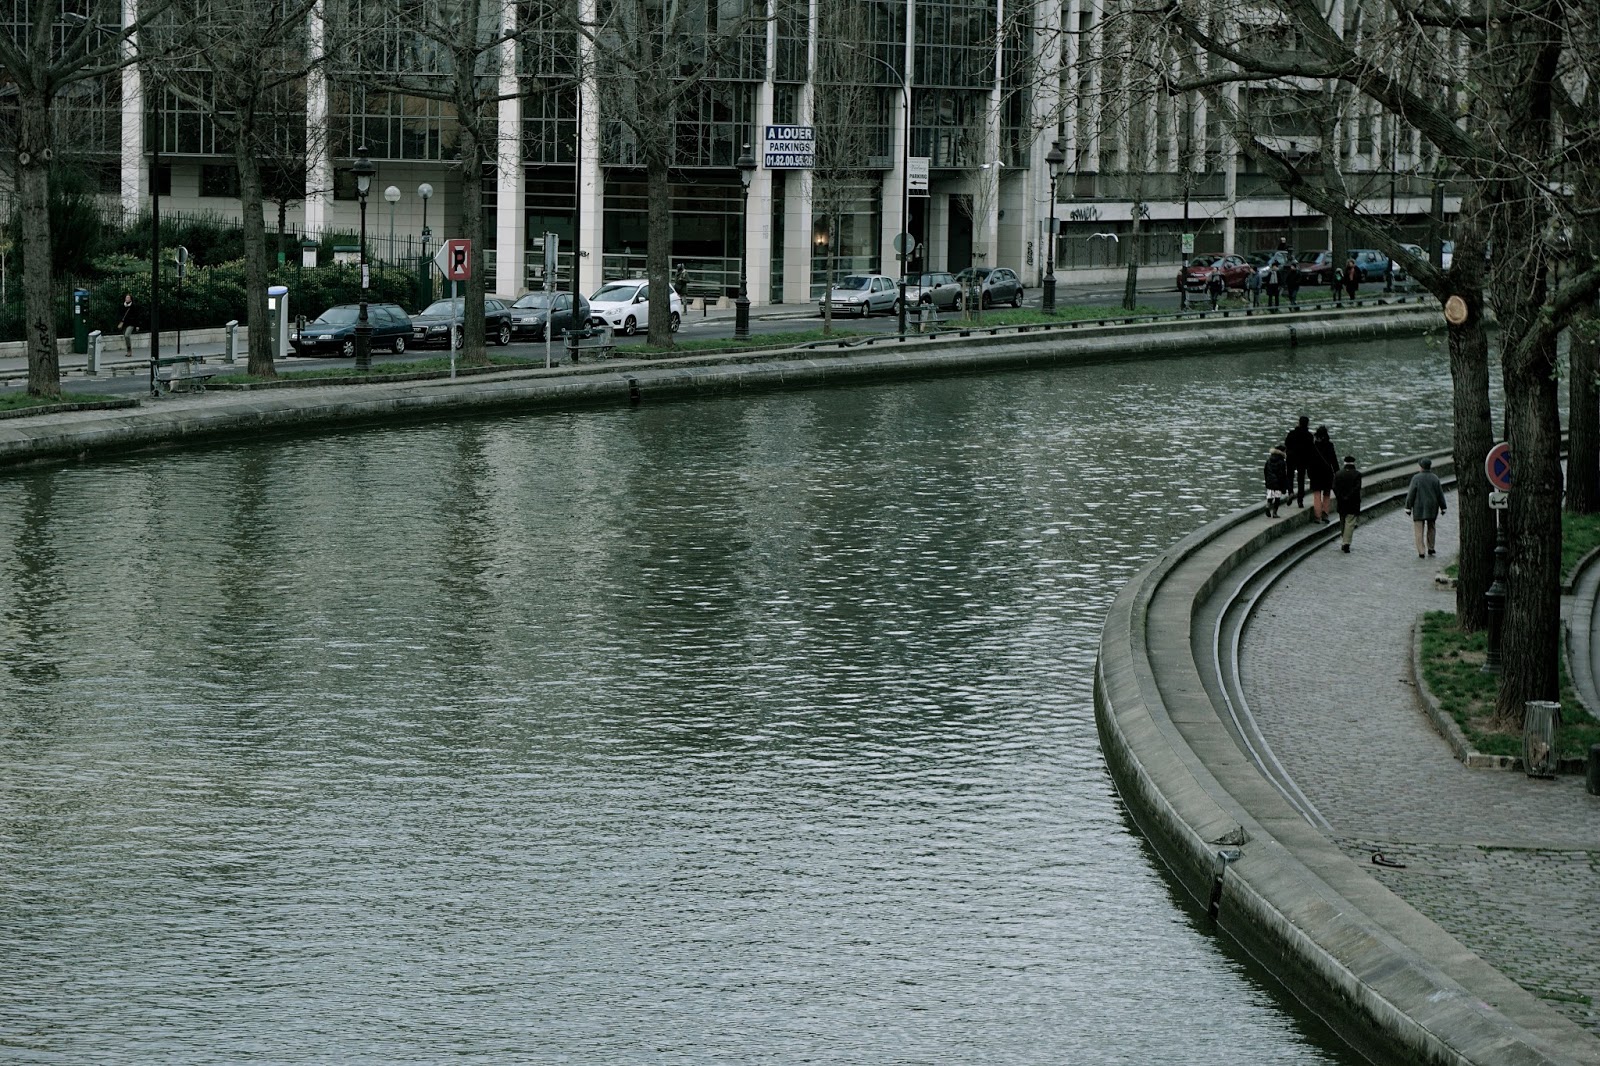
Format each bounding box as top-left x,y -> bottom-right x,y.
1422,611 -> 1600,759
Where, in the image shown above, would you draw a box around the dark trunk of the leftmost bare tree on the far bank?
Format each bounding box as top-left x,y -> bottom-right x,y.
16,93 -> 61,399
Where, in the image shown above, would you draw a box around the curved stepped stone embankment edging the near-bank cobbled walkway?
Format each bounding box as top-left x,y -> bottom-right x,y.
1094,461 -> 1600,1066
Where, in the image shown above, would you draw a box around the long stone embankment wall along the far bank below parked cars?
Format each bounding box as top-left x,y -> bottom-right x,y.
0,303 -> 1440,466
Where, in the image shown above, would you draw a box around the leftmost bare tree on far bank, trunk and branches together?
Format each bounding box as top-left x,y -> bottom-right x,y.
0,0 -> 165,397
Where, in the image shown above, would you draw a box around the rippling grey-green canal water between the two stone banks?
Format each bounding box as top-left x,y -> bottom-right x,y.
0,341 -> 1450,1066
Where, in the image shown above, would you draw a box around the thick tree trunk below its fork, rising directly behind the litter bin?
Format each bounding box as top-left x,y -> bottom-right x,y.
1494,332 -> 1562,728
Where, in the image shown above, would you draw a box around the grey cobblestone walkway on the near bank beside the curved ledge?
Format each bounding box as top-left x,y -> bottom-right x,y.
1240,496 -> 1600,1036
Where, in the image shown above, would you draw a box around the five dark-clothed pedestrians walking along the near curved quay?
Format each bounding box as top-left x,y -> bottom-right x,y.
1262,415 -> 1445,559
